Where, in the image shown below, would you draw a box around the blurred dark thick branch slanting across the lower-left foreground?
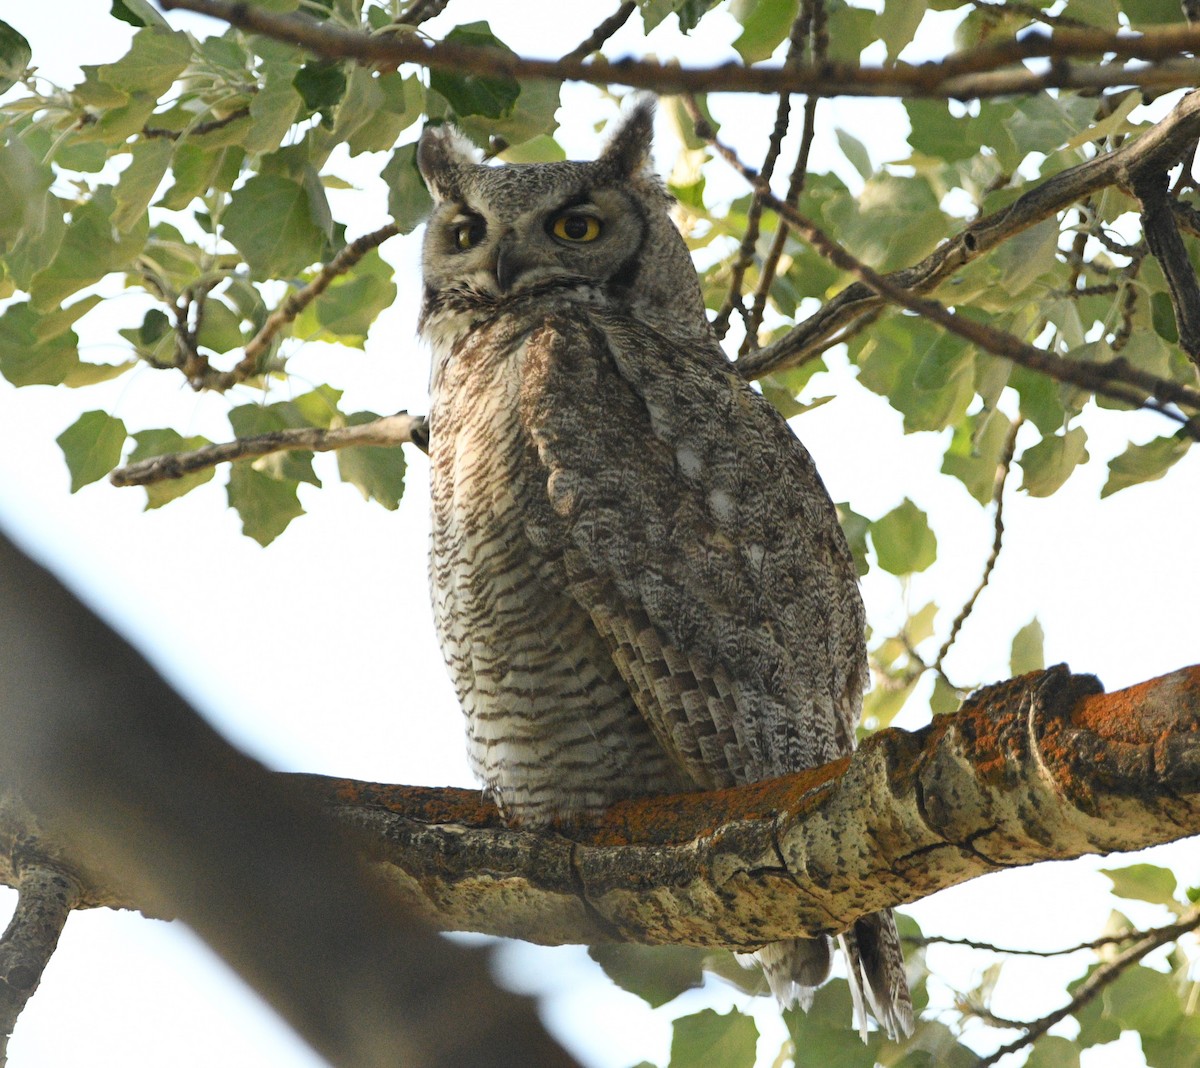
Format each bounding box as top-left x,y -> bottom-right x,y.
0,538 -> 574,1068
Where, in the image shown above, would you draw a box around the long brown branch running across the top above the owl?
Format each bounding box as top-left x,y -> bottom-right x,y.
160,0 -> 1200,100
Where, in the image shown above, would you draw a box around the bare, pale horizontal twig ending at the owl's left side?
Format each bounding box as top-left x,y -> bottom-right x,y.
108,412 -> 428,486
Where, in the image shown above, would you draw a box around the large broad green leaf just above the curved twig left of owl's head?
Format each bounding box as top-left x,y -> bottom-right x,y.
223,174 -> 325,278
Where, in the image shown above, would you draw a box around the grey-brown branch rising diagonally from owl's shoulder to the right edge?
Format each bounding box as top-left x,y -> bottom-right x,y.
738,92 -> 1200,378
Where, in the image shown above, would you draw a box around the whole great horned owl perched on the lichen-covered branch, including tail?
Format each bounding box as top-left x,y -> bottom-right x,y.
418,101 -> 912,1034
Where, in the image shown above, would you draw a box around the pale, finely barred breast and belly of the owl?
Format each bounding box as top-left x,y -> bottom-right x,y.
430,303 -> 686,823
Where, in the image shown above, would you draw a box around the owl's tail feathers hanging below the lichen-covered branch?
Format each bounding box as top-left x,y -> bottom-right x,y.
737,912 -> 913,1042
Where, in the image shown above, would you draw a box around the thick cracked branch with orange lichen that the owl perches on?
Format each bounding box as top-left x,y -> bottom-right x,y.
9,666 -> 1200,949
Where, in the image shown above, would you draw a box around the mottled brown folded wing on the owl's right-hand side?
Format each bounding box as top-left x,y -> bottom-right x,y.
520,314 -> 865,787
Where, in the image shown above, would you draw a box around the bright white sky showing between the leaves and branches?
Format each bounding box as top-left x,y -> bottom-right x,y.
0,0 -> 1200,1068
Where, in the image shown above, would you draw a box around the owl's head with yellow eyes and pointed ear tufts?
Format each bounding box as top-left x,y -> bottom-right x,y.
416,98 -> 708,337
